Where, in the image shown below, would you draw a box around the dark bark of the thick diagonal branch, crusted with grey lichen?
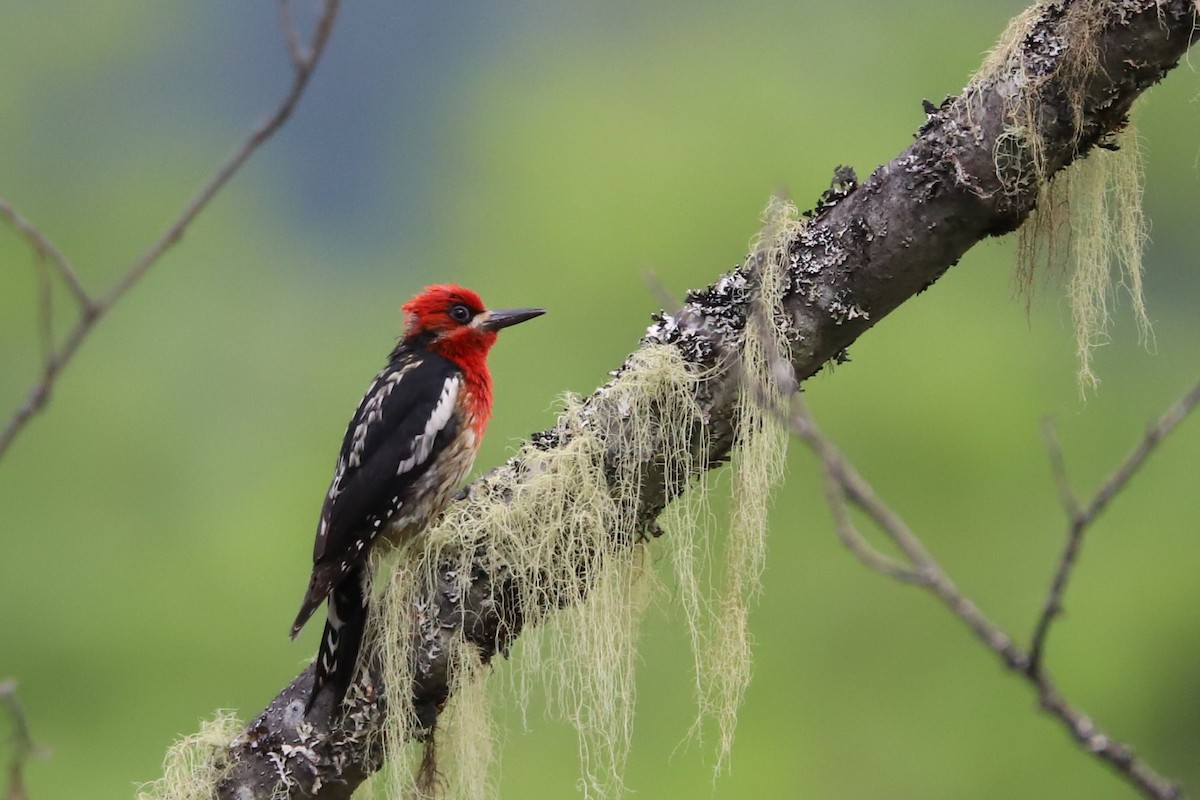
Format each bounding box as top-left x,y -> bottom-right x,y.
208,0 -> 1198,800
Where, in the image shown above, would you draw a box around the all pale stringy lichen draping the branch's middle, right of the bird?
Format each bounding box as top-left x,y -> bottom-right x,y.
360,203 -> 799,798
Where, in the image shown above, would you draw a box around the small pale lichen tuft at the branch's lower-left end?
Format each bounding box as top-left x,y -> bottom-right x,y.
138,710 -> 241,800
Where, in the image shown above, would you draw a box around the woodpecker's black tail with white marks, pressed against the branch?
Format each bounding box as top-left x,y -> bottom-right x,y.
305,564 -> 367,714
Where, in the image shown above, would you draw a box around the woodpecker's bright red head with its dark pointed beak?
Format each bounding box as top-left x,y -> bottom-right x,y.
403,285 -> 546,371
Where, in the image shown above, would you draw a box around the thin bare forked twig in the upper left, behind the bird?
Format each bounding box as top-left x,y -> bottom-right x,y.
0,0 -> 341,458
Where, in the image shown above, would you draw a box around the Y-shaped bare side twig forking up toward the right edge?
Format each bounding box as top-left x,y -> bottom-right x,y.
1027,383 -> 1200,676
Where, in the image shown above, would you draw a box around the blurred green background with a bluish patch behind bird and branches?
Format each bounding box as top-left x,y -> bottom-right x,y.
0,0 -> 1200,800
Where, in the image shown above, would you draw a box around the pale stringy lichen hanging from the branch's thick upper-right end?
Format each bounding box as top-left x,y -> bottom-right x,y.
965,0 -> 1152,391
